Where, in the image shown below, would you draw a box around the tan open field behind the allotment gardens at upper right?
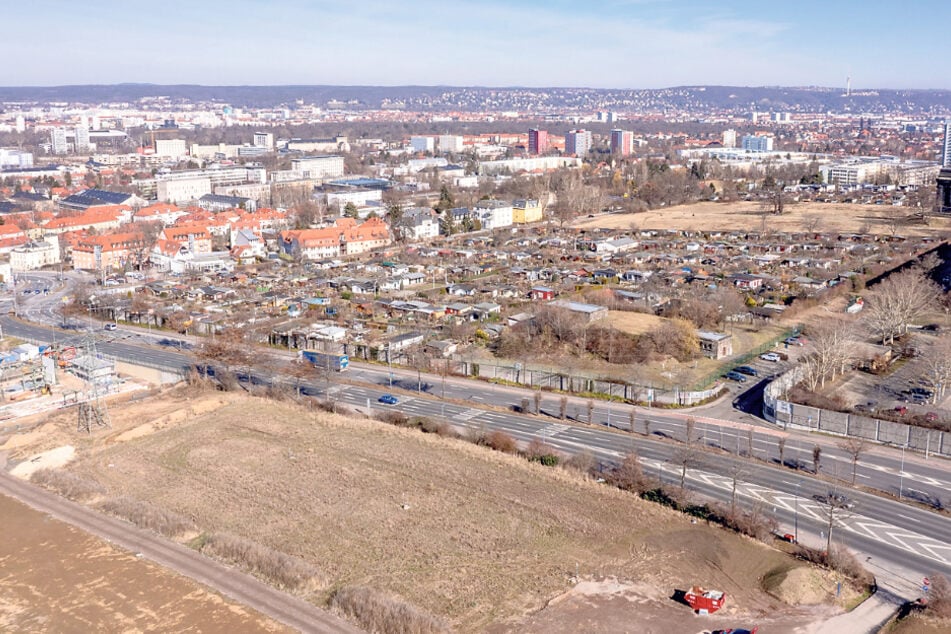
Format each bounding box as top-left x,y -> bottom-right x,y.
575,202 -> 951,236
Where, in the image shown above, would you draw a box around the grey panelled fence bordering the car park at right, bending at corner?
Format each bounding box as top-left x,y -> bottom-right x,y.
763,367 -> 951,457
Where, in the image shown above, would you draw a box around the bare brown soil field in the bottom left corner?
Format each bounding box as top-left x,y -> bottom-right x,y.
0,496 -> 290,634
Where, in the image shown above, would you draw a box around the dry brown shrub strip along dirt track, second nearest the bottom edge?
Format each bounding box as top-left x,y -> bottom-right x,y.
198,533 -> 327,590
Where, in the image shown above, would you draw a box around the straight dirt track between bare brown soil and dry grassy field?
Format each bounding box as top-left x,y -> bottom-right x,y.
0,473 -> 360,634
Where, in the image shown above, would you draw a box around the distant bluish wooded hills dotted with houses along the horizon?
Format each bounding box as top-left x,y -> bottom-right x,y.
0,83 -> 951,116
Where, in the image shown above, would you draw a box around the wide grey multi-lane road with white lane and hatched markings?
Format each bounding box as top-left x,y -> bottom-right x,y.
0,276 -> 951,598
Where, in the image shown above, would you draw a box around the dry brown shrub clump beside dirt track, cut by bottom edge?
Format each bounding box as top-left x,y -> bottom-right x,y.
330,586 -> 449,634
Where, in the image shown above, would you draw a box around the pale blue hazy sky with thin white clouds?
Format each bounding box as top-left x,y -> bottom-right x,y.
13,0 -> 951,89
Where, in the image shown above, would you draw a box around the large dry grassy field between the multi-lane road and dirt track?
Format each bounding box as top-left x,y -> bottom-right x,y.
0,392 -> 864,634
